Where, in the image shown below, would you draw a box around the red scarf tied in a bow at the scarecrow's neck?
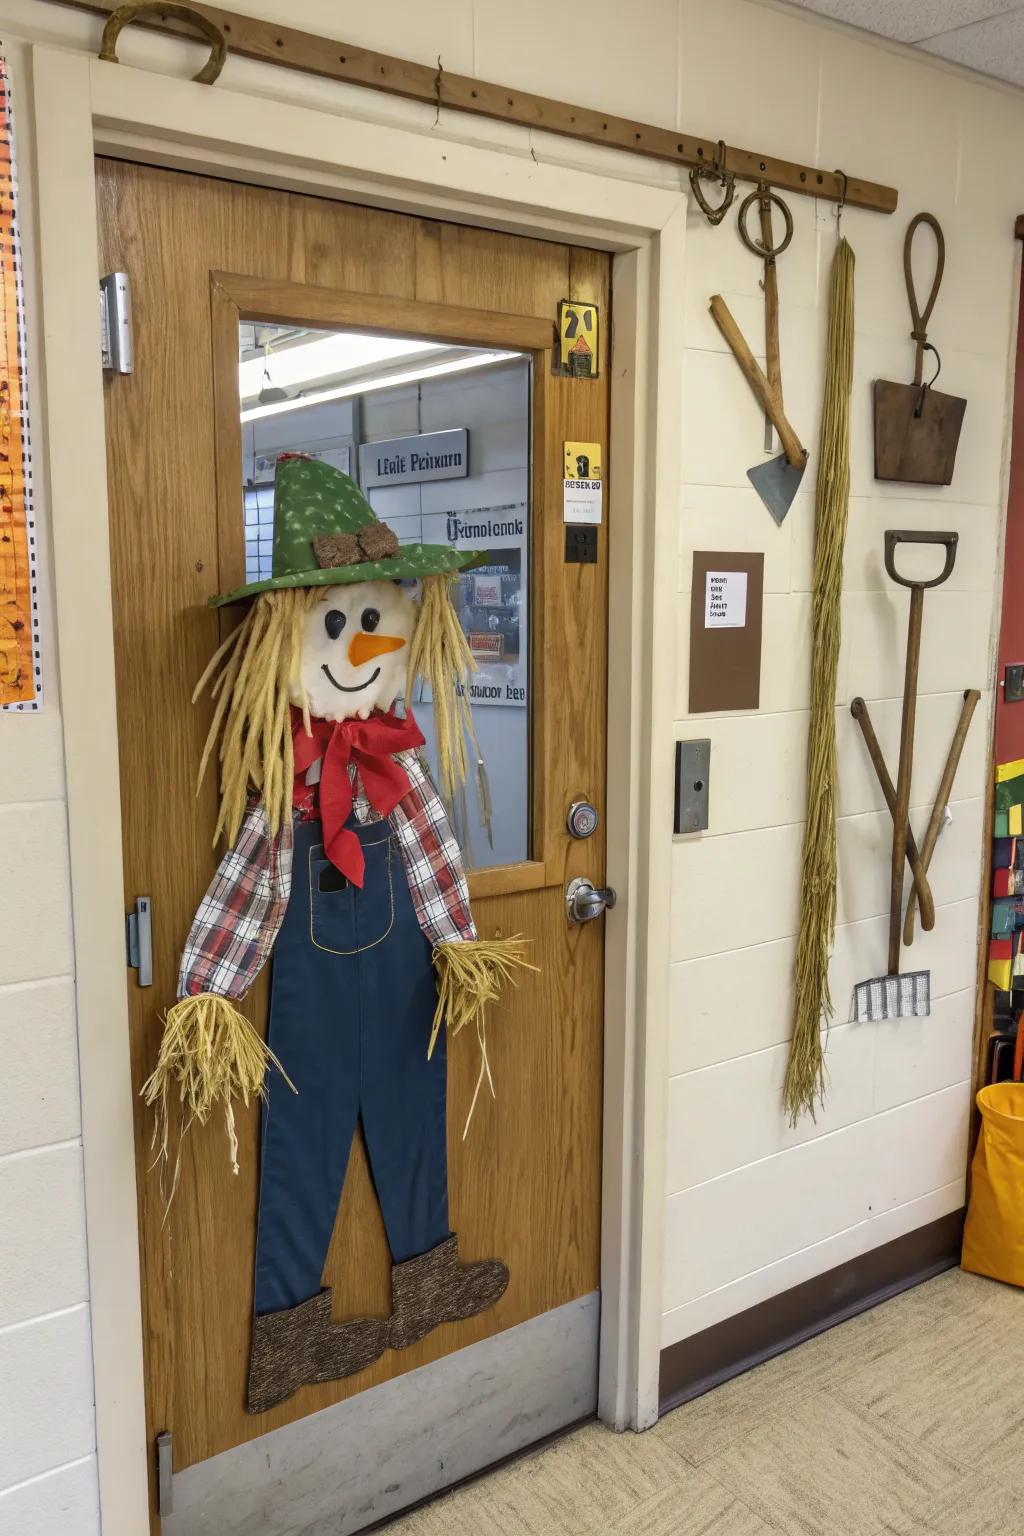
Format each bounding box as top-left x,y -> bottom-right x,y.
292,708 -> 424,888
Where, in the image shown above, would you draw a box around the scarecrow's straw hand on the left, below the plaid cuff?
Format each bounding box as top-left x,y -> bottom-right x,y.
141,992 -> 295,1207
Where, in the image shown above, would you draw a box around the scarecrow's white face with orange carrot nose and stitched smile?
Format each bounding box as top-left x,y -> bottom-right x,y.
292,581 -> 416,720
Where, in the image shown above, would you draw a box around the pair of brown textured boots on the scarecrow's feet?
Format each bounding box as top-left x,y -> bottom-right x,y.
249,1233 -> 508,1413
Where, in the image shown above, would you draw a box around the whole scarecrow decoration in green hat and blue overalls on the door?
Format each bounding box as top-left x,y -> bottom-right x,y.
143,455 -> 525,1413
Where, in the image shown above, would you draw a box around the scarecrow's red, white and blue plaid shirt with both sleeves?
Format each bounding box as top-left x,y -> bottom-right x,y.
178,753 -> 476,998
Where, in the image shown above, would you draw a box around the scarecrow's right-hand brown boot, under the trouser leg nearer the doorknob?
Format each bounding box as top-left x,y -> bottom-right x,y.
387,1233 -> 508,1349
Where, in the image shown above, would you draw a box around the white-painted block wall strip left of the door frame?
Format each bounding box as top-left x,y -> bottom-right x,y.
0,34 -> 100,1536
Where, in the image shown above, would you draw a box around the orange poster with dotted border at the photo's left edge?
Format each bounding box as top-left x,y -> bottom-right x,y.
0,55 -> 41,711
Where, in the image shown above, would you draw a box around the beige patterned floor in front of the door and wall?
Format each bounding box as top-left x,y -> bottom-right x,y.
388,1270 -> 1024,1536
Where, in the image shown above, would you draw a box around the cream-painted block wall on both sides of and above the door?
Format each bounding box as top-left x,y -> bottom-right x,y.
0,0 -> 1024,1517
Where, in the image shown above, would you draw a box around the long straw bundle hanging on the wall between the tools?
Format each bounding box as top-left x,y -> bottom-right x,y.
783,240 -> 854,1124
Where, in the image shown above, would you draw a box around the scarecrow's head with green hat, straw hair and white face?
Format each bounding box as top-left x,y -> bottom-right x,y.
197,455 -> 479,842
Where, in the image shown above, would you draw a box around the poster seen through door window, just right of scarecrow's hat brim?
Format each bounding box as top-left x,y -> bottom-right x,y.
422,501 -> 530,710
